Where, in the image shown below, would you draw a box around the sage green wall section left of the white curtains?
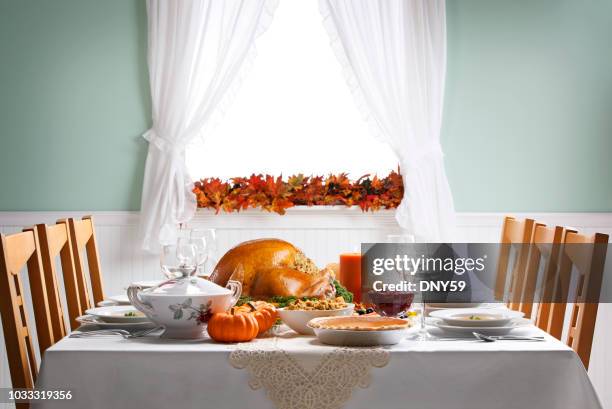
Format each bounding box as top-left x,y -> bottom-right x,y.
0,0 -> 150,210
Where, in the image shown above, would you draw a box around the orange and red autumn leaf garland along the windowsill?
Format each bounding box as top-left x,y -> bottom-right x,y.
193,169 -> 404,214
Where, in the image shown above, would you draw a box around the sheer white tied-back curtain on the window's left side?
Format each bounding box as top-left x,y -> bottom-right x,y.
140,0 -> 278,251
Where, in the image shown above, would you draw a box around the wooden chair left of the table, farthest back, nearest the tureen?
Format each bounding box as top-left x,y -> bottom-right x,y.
57,216 -> 105,316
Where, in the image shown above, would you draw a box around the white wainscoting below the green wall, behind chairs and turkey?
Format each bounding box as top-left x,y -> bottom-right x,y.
0,207 -> 612,409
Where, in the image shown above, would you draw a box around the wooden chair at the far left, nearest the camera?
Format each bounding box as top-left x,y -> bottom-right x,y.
0,230 -> 53,396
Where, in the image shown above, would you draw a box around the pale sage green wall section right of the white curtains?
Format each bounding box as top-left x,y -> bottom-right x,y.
443,0 -> 612,211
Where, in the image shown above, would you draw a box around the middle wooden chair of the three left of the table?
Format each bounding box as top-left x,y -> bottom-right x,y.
35,223 -> 81,332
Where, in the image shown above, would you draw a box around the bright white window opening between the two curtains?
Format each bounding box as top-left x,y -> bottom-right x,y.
187,0 -> 398,178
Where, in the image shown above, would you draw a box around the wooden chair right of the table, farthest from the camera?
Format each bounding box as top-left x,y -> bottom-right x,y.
495,216 -> 534,309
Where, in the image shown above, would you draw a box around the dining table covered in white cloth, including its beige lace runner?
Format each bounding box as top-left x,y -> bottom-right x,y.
33,326 -> 601,409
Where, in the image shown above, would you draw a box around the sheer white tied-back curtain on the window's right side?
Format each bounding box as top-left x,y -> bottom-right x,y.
319,0 -> 455,242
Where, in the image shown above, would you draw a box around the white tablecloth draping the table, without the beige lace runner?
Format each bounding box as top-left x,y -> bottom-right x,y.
34,328 -> 601,409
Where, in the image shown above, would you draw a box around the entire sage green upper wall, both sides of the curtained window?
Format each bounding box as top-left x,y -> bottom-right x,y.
0,0 -> 612,211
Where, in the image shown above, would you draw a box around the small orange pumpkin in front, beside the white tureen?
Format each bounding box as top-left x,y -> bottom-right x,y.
208,308 -> 259,342
